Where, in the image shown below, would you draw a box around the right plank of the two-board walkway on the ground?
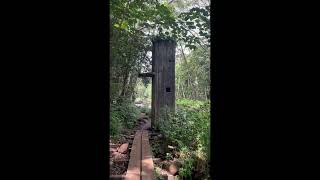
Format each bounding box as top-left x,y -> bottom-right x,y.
141,131 -> 155,180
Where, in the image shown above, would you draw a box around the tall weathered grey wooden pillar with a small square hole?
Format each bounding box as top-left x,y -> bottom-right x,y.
151,40 -> 176,127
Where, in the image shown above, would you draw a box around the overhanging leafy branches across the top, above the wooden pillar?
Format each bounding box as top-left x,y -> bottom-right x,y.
110,0 -> 210,50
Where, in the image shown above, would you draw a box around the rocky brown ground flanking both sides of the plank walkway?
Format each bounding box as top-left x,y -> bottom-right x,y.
109,113 -> 179,179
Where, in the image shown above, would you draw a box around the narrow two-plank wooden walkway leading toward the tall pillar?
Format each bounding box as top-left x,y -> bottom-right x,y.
125,130 -> 155,180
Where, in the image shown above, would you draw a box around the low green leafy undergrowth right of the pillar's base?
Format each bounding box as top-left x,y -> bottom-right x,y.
159,99 -> 210,177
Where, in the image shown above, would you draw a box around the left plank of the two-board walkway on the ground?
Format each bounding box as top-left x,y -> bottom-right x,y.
125,131 -> 142,180
